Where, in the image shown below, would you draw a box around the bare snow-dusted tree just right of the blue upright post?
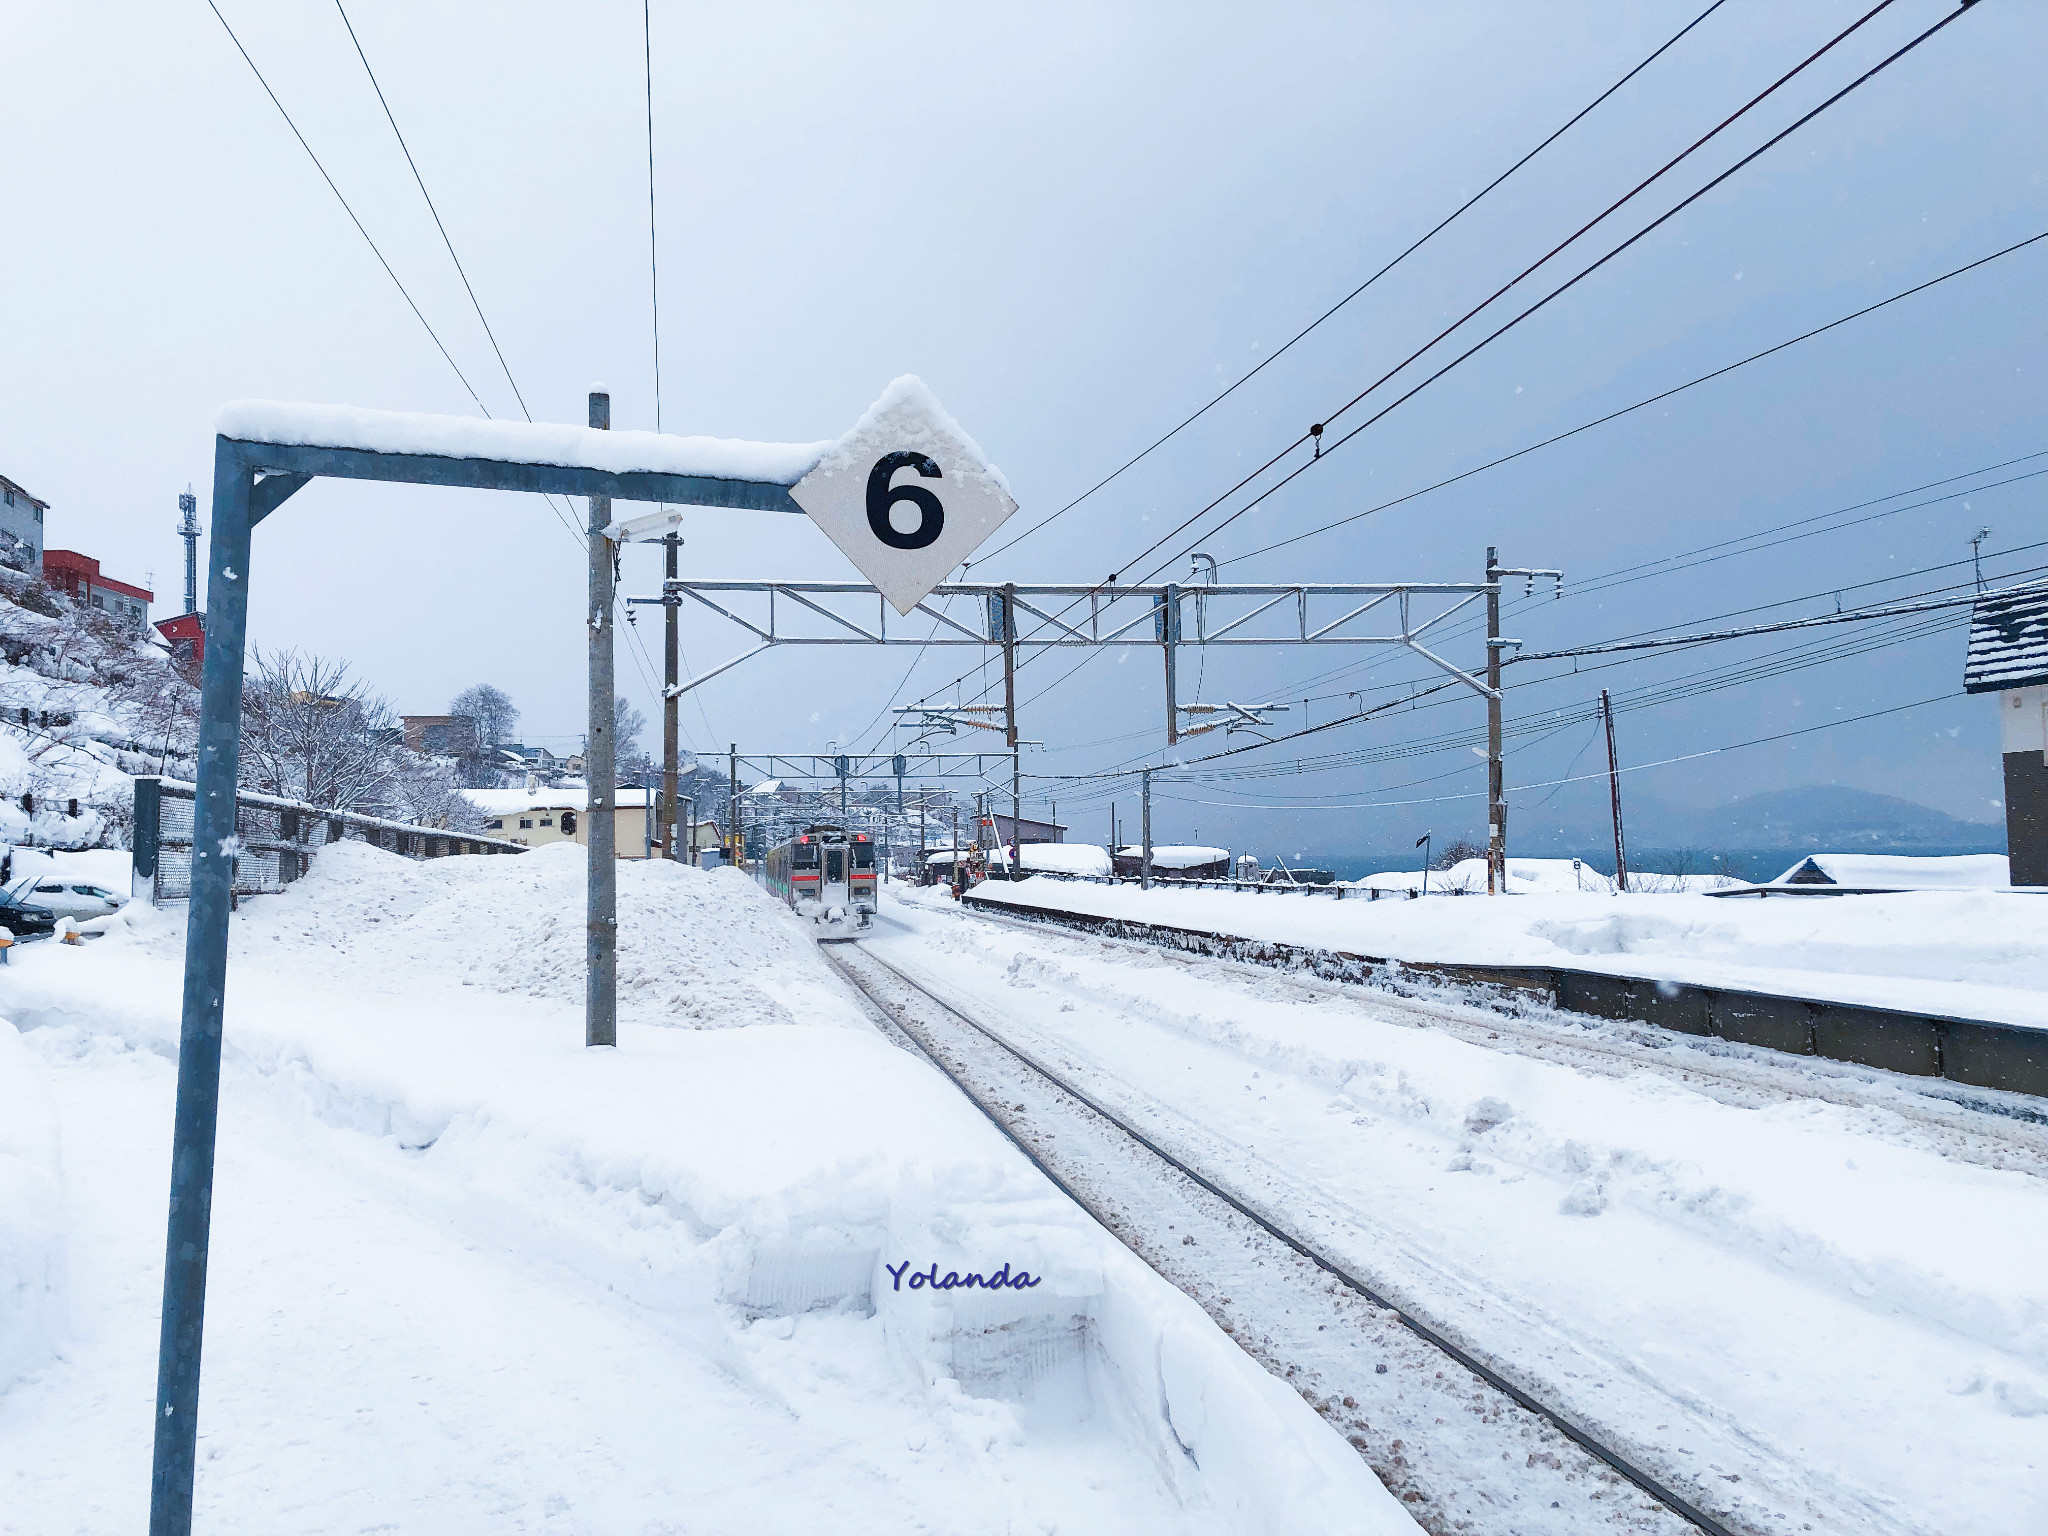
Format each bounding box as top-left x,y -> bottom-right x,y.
242,651 -> 397,811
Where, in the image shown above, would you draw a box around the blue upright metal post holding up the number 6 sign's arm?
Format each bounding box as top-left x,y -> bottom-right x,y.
150,442 -> 254,1536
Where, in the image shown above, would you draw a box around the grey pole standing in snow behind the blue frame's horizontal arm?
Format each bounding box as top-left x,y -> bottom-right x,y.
584,391 -> 618,1044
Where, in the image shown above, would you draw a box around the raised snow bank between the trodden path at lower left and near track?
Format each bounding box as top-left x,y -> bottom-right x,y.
8,844 -> 1413,1536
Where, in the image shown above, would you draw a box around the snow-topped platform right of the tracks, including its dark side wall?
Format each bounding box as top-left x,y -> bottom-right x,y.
969,879 -> 2048,1094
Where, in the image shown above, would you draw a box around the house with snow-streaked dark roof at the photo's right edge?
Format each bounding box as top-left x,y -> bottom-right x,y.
1962,582 -> 2048,885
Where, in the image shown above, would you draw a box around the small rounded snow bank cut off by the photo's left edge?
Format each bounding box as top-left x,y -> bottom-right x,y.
0,1020 -> 63,1391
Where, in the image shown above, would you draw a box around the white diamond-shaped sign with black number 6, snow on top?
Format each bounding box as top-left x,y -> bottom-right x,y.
791,375 -> 1018,614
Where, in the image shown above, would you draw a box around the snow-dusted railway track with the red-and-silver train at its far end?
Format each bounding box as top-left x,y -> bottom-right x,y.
825,946 -> 1761,1536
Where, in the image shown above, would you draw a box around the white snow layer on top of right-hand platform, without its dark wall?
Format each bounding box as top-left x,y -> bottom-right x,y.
975,860 -> 2048,1028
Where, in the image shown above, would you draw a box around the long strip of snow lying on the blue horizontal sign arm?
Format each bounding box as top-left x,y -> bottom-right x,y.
213,399 -> 834,485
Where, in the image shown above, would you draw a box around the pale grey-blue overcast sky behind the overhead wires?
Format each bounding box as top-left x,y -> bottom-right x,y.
0,0 -> 2048,844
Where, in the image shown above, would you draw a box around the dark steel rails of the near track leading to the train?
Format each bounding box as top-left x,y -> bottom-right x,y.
821,946 -> 1737,1536
